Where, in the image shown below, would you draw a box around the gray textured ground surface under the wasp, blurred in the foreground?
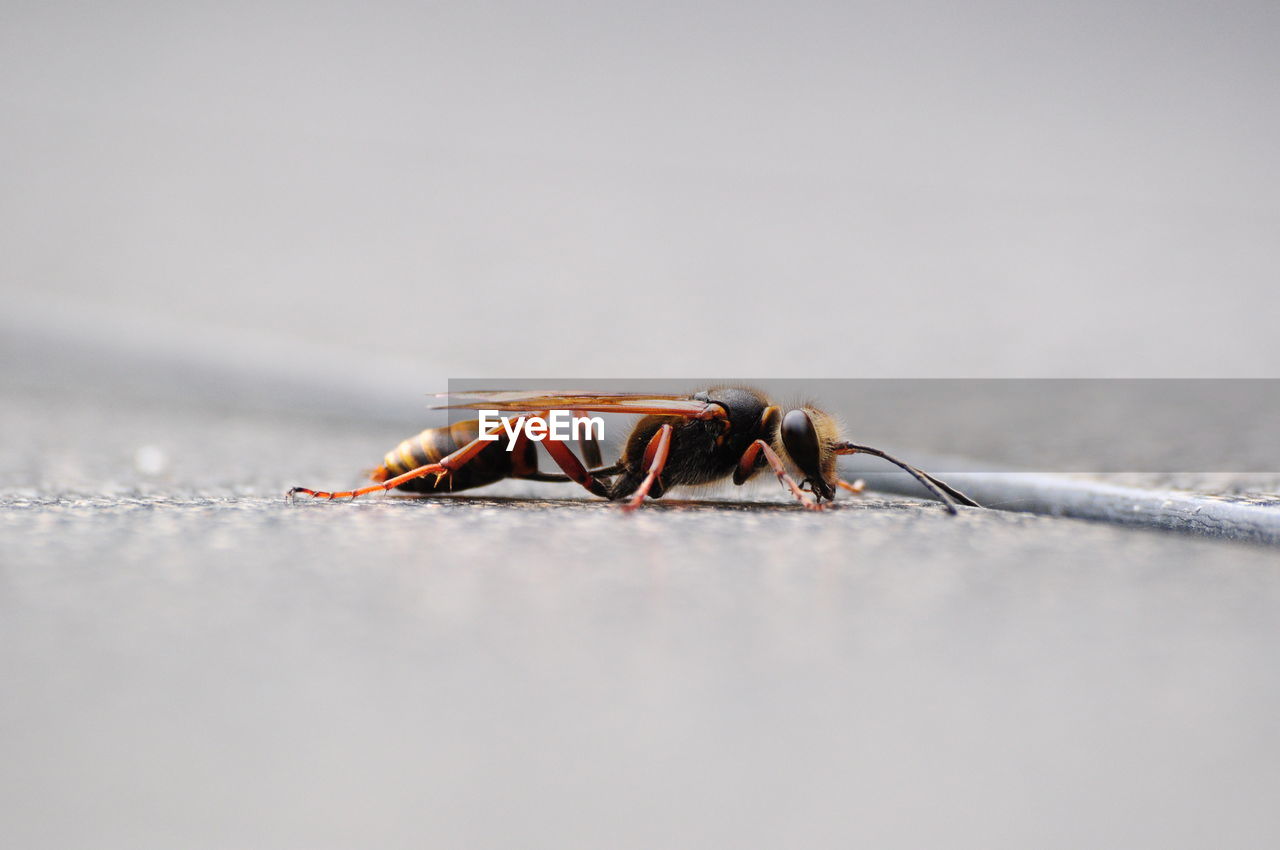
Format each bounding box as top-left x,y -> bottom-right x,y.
0,373 -> 1280,847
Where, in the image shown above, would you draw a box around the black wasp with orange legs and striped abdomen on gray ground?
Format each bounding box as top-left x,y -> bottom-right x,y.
288,387 -> 980,515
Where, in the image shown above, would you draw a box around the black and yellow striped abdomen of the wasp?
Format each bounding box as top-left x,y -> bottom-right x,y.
370,419 -> 536,493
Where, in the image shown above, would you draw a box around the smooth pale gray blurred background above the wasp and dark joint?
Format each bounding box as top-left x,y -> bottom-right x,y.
0,0 -> 1280,384
